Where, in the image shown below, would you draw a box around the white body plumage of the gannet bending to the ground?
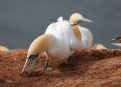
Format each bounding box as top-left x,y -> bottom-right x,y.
45,17 -> 76,63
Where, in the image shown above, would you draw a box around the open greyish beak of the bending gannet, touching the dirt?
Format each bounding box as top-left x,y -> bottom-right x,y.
21,55 -> 38,75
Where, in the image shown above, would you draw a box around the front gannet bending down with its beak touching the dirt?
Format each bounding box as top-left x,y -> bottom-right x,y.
22,17 -> 76,74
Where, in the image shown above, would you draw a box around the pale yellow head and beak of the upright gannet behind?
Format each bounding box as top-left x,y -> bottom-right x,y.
69,13 -> 93,25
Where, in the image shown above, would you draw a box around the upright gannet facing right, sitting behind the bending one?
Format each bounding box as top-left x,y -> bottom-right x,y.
69,13 -> 93,48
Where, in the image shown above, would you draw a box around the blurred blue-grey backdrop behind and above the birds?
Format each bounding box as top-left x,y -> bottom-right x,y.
0,0 -> 121,49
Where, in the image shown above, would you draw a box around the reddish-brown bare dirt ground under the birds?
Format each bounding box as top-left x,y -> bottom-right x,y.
0,49 -> 121,87
